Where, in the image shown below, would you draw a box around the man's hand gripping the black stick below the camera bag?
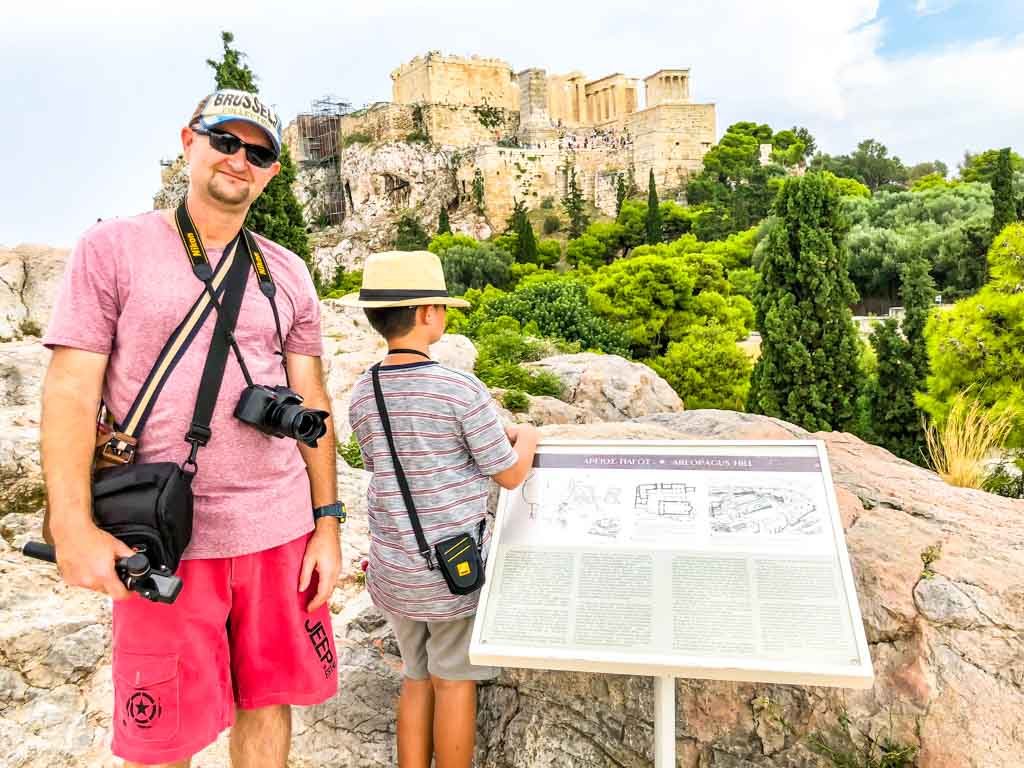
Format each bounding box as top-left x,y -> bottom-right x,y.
54,522 -> 135,600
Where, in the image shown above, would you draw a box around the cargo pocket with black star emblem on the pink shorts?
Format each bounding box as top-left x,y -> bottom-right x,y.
114,653 -> 180,741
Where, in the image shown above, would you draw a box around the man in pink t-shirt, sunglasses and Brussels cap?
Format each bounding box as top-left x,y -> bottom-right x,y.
42,91 -> 344,768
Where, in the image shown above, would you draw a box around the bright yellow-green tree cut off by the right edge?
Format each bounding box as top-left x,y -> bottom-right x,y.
919,224 -> 1024,449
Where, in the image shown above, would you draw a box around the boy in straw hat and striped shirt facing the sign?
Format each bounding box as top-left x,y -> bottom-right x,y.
342,251 -> 538,768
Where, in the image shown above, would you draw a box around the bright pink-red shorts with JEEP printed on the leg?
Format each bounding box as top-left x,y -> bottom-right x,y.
112,535 -> 338,764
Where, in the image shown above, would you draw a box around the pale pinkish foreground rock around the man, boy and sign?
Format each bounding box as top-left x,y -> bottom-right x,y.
0,262 -> 1024,768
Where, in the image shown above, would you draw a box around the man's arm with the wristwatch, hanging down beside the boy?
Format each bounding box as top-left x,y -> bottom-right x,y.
287,352 -> 341,611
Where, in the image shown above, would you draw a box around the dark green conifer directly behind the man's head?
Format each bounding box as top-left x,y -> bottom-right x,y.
206,32 -> 312,271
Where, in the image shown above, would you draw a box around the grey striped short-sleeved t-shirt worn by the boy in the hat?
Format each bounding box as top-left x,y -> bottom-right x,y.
348,360 -> 516,622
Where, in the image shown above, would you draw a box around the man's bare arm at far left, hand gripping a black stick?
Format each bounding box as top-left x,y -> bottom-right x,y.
40,346 -> 133,599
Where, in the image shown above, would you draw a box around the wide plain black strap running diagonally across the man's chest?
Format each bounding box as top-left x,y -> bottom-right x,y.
185,230 -> 252,472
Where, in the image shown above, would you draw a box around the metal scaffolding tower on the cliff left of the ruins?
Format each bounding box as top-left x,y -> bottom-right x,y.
297,96 -> 352,224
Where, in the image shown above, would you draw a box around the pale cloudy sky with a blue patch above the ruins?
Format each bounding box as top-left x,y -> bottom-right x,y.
0,0 -> 1024,247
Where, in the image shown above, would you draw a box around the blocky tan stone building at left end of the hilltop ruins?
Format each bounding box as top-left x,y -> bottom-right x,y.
391,52 -> 519,111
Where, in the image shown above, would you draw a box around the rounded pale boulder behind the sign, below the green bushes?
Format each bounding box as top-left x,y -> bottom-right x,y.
526,352 -> 683,422
